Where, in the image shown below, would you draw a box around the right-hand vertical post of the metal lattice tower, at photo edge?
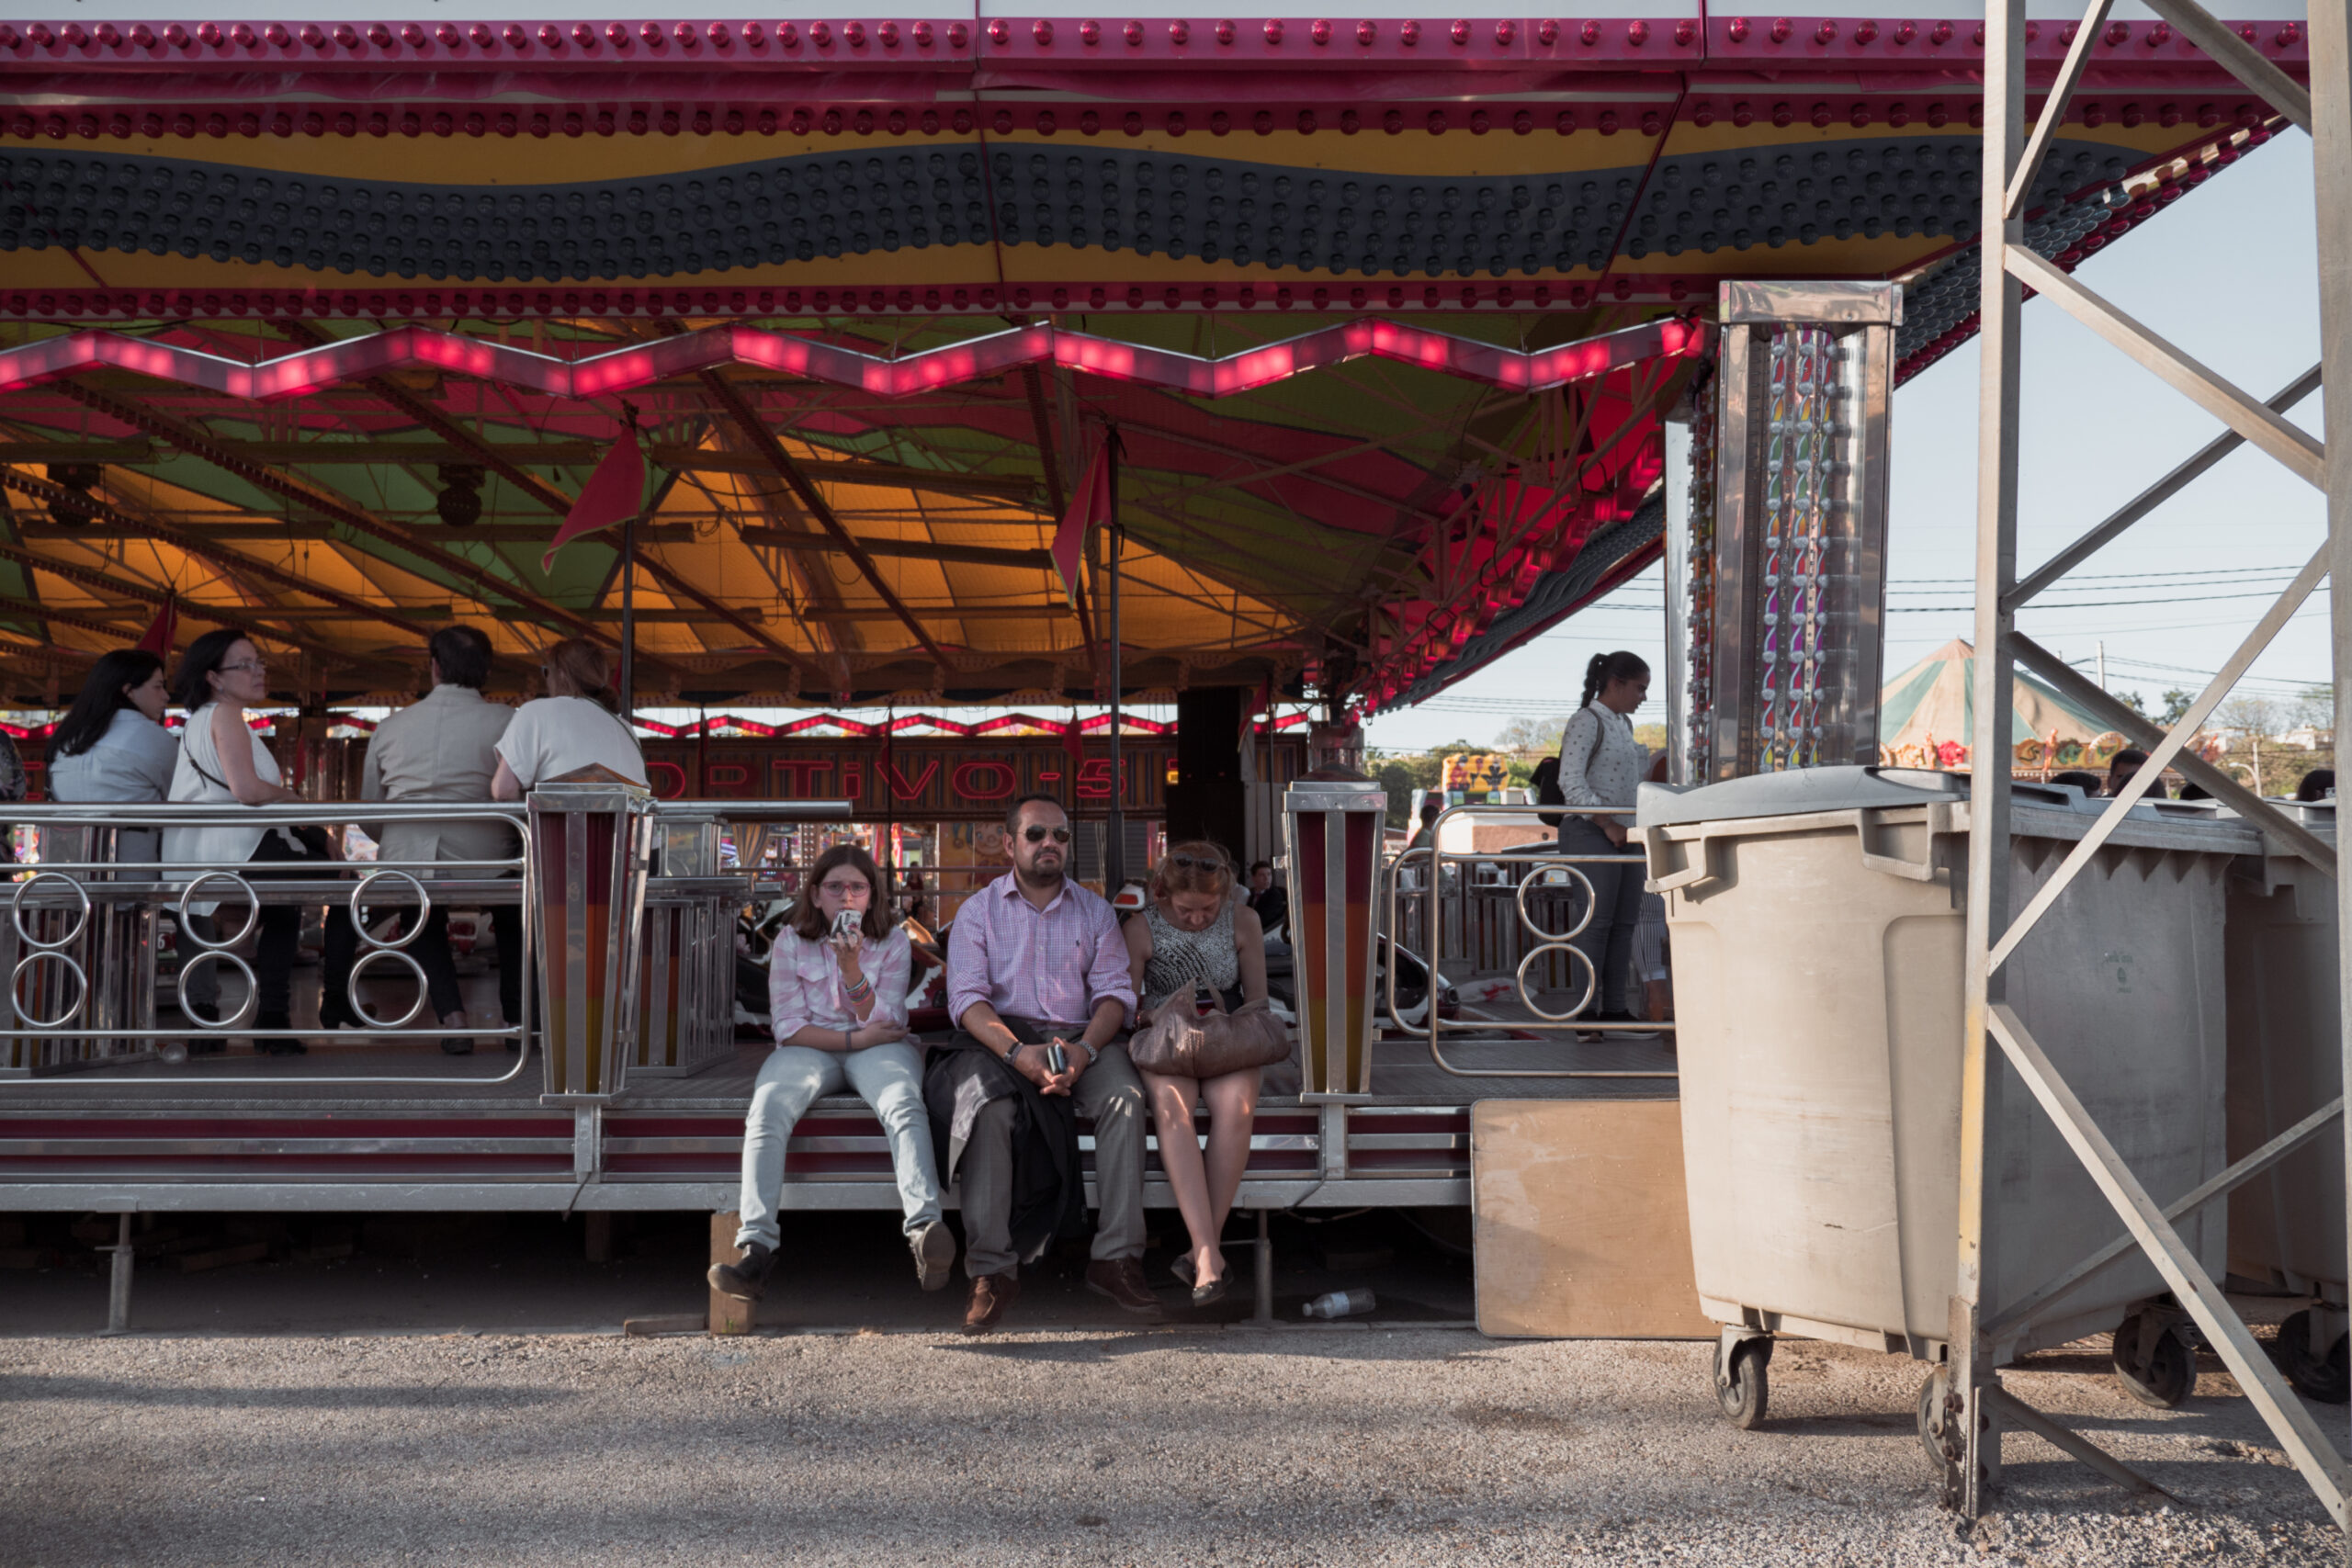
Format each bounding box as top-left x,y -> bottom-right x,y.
2310,0 -> 2352,1504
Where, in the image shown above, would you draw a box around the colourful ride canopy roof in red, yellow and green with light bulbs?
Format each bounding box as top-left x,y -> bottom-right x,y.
0,0 -> 2307,710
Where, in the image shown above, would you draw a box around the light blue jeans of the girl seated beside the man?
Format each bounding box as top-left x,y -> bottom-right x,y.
736,1039 -> 938,1251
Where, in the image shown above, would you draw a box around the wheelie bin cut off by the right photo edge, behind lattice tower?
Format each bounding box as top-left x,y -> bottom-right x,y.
2227,802 -> 2352,1404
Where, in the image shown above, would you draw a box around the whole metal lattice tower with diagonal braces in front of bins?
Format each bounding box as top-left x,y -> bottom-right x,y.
1943,0 -> 2352,1528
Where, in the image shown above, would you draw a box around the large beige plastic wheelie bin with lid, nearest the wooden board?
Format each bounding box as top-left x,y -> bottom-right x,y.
1637,766 -> 2258,1425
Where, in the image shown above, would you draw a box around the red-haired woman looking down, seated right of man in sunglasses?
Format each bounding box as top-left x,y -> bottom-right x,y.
1126,840 -> 1265,1307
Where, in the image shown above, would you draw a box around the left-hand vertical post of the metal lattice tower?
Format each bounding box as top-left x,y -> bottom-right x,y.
1945,0 -> 2025,1518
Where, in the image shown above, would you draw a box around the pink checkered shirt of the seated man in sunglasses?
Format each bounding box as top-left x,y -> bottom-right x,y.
948,872 -> 1136,1032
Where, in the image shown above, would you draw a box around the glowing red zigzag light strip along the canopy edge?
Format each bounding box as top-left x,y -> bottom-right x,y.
0,317 -> 1710,402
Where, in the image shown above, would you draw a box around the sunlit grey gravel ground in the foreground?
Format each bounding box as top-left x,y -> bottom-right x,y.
0,1328 -> 2343,1568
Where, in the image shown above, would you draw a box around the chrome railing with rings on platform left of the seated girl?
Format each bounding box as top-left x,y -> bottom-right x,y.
0,802 -> 852,1098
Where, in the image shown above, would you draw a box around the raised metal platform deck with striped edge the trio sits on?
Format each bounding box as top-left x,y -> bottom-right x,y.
0,1039 -> 1675,1213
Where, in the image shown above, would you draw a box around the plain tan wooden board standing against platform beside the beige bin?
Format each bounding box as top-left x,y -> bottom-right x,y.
1470,1100 -> 1717,1340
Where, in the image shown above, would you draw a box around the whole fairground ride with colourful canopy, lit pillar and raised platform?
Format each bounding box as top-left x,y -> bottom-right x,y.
0,0 -> 2340,1532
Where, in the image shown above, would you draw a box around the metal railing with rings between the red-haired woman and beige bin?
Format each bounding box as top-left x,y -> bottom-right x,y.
1383,807 -> 1679,1079
